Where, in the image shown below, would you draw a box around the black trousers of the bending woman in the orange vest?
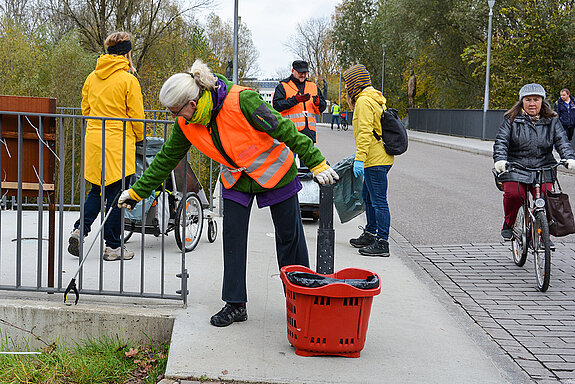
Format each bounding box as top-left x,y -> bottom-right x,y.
222,194 -> 309,303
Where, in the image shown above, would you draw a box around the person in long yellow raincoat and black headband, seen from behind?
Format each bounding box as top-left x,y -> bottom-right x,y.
68,32 -> 144,261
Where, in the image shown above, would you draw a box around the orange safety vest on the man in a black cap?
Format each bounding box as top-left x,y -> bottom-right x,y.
280,80 -> 319,143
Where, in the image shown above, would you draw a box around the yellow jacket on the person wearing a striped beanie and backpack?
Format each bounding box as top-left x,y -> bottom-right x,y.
352,87 -> 394,167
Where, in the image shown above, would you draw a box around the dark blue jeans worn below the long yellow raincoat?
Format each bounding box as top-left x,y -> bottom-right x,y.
74,176 -> 130,248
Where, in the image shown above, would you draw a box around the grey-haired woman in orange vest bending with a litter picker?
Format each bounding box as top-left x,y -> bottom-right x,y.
118,60 -> 339,327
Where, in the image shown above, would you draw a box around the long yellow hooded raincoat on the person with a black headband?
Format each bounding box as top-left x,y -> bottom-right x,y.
82,55 -> 144,185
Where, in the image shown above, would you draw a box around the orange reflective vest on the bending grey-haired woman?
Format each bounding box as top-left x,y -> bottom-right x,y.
178,85 -> 294,189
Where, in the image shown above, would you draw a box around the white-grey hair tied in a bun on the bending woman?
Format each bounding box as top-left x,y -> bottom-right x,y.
159,60 -> 217,109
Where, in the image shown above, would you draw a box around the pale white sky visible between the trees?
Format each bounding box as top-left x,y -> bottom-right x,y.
207,0 -> 341,79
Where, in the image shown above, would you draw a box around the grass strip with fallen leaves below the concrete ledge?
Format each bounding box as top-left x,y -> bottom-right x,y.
0,338 -> 169,384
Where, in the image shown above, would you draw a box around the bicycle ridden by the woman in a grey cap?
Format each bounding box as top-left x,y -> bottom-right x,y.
506,161 -> 566,292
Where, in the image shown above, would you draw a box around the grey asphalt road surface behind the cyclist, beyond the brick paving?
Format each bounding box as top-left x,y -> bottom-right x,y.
318,126 -> 575,246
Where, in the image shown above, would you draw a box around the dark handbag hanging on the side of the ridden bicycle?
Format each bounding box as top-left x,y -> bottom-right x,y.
545,180 -> 575,237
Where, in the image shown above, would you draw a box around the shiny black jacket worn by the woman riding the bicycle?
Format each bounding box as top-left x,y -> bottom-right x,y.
493,115 -> 575,184
